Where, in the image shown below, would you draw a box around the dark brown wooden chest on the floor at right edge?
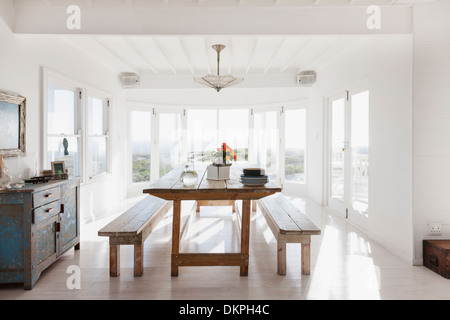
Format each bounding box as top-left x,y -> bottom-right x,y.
423,240 -> 450,279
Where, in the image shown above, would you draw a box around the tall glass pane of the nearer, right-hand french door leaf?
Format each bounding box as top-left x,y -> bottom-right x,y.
351,91 -> 369,213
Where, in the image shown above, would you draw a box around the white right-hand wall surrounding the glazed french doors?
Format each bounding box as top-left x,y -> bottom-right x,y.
307,36 -> 413,261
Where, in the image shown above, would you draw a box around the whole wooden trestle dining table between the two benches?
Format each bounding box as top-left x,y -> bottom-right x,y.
143,164 -> 281,276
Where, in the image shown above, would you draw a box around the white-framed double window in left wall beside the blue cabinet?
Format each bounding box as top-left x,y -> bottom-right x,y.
43,70 -> 110,182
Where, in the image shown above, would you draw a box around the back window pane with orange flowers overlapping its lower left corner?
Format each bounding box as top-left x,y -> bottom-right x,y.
219,109 -> 249,161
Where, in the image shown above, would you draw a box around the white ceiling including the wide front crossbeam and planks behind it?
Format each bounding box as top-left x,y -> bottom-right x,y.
7,0 -> 413,89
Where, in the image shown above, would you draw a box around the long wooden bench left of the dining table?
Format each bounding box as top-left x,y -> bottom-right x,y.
98,195 -> 173,277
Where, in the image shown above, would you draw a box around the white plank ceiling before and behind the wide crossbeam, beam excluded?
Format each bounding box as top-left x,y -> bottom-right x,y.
13,0 -> 426,86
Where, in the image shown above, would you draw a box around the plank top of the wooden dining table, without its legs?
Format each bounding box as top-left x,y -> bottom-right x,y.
143,164 -> 281,200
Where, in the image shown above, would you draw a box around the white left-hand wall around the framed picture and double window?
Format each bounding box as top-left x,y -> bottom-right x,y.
0,19 -> 124,221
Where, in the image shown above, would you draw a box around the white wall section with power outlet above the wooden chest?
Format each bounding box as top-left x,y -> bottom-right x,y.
413,3 -> 450,264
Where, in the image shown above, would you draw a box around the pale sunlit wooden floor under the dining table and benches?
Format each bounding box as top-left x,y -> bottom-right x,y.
0,198 -> 450,300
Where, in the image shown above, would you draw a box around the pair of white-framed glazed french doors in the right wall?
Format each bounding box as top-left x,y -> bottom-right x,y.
328,90 -> 369,223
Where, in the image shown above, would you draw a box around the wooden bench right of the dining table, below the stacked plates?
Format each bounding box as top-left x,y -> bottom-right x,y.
257,194 -> 321,275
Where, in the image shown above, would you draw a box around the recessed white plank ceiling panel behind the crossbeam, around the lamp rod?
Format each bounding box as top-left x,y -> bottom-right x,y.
61,36 -> 361,76
